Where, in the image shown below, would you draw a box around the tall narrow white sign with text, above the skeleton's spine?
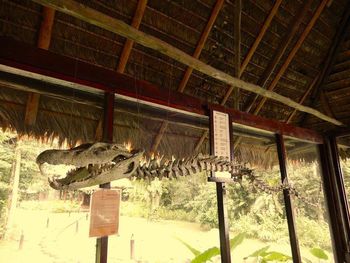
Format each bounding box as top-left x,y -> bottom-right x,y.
211,110 -> 231,178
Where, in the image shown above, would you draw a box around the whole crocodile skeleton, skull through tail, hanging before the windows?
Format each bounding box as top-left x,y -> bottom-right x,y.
36,142 -> 298,201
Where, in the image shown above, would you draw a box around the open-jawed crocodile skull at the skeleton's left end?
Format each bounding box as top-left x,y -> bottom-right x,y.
36,142 -> 143,190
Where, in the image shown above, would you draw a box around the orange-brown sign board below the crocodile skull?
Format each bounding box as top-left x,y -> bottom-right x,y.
89,189 -> 121,237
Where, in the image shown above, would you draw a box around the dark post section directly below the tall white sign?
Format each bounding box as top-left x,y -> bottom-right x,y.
216,182 -> 231,263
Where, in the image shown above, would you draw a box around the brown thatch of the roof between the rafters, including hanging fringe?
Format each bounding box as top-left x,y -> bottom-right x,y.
0,0 -> 350,165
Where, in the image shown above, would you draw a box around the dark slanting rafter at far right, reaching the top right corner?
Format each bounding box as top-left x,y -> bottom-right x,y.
300,1 -> 350,125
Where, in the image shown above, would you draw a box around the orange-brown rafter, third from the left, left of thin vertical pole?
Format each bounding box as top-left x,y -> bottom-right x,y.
152,0 -> 224,152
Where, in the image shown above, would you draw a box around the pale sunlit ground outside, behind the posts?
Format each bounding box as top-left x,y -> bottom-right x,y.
0,209 -> 332,263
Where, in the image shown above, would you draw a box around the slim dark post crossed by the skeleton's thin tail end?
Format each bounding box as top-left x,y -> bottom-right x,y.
276,134 -> 301,263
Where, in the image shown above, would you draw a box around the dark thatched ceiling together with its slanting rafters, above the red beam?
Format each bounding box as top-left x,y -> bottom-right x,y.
0,0 -> 350,150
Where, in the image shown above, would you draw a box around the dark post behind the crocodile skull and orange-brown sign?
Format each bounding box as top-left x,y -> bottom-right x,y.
96,92 -> 114,263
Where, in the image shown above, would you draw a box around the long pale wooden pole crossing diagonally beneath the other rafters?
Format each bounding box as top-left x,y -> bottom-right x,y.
33,0 -> 342,125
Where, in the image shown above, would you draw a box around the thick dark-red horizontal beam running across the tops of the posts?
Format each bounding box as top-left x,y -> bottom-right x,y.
0,36 -> 322,142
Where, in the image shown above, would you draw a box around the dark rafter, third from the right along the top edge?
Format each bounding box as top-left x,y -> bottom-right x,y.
244,0 -> 314,112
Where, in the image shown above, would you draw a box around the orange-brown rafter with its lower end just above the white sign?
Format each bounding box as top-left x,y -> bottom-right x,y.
220,0 -> 282,105
